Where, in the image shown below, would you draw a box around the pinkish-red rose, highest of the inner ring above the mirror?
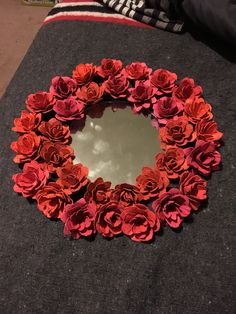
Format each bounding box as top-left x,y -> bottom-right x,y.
103,75 -> 129,99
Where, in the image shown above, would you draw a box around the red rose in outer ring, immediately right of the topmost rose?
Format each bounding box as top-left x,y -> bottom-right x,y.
122,62 -> 152,81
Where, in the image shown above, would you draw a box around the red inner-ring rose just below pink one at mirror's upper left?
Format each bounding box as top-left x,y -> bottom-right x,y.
39,118 -> 71,144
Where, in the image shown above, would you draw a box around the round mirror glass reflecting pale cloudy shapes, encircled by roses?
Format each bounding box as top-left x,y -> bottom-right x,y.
71,103 -> 161,187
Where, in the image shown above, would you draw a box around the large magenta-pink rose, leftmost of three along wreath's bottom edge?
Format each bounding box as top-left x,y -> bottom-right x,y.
61,198 -> 96,239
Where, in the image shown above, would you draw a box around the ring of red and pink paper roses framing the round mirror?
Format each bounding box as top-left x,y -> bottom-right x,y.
11,59 -> 223,242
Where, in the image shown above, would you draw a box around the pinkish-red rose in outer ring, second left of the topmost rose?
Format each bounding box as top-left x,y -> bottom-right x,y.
50,76 -> 78,99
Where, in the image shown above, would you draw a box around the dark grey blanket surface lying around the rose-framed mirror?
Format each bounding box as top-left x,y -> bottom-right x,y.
0,21 -> 236,314
